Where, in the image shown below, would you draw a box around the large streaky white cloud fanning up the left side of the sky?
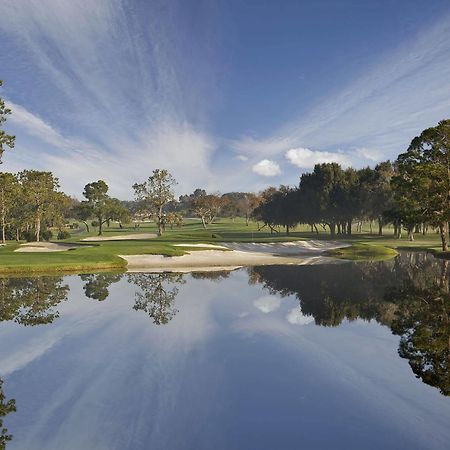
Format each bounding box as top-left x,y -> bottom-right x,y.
0,0 -> 216,197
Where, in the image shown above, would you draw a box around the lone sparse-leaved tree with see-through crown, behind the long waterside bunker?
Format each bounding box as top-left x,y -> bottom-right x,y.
133,169 -> 176,236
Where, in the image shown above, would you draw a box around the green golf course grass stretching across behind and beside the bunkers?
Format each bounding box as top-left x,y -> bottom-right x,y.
0,219 -> 442,273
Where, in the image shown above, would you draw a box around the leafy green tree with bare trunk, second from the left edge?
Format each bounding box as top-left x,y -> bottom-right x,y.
19,170 -> 60,242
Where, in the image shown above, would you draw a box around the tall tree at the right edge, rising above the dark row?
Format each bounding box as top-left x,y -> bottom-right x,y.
393,120 -> 450,251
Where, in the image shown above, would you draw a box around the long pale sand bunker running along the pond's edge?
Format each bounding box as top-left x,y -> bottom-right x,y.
119,241 -> 349,272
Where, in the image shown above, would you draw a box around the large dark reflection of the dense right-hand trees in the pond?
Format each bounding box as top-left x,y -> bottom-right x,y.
250,253 -> 450,395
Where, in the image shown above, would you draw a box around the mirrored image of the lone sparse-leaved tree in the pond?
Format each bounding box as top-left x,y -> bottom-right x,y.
128,273 -> 184,325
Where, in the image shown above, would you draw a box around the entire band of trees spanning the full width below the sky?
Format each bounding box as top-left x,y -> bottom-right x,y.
0,81 -> 450,251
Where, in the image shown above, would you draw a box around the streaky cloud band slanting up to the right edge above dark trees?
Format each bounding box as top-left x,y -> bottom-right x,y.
233,15 -> 450,171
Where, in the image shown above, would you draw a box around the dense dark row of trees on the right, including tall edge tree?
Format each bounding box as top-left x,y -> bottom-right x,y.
253,120 -> 450,251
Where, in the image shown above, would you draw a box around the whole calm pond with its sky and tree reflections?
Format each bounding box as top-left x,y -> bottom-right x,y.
0,253 -> 450,450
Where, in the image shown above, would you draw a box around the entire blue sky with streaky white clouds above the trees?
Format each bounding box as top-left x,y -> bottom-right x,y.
0,0 -> 450,199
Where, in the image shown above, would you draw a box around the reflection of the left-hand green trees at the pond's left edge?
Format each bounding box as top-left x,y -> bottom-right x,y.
0,277 -> 69,326
